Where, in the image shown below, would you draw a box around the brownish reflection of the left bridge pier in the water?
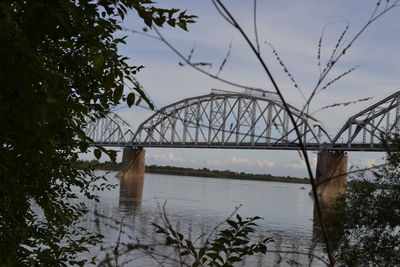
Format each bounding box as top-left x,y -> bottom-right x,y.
119,172 -> 144,213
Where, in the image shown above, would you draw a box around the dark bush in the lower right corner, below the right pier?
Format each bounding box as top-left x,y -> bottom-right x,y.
329,140 -> 400,266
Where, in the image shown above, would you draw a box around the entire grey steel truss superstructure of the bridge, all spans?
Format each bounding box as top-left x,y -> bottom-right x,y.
85,89 -> 400,151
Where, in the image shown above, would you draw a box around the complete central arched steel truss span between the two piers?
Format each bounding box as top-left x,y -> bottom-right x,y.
127,91 -> 331,150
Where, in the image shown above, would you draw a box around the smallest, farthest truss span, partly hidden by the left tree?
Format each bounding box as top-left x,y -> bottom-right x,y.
84,113 -> 134,146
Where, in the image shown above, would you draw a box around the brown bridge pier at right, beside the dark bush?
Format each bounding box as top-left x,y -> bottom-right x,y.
316,151 -> 348,207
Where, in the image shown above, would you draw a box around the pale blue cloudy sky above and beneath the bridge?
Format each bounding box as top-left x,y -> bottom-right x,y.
83,0 -> 400,177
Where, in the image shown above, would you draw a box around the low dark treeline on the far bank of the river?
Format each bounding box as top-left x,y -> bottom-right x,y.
80,160 -> 310,184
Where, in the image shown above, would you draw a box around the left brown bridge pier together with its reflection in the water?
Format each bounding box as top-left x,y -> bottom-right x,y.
119,147 -> 146,210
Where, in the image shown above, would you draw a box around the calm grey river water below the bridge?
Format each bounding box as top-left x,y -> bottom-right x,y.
82,171 -> 324,266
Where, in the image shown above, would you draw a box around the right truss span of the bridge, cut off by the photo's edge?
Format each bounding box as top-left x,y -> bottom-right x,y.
332,91 -> 400,151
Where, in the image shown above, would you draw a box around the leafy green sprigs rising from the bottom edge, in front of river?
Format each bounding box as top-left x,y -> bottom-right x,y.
153,214 -> 272,267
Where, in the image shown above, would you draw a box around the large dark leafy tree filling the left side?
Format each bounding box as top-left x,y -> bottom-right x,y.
0,0 -> 194,266
